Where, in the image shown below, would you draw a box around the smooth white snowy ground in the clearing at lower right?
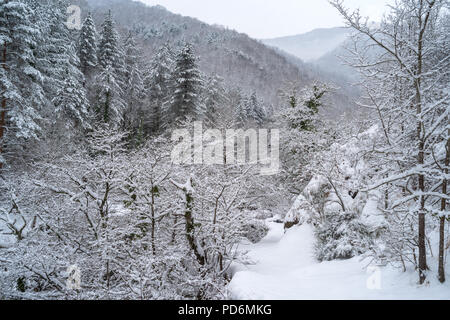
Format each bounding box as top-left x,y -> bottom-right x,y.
229,221 -> 450,300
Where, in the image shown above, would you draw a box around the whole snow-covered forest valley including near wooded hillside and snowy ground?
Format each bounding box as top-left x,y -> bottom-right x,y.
0,0 -> 450,300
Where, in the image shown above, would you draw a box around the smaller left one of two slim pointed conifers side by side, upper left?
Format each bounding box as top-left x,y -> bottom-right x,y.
78,12 -> 97,76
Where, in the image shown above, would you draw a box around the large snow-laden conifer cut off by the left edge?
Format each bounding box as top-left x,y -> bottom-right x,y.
0,0 -> 45,168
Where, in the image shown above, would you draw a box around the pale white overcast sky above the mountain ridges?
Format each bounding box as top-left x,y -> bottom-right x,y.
140,0 -> 388,39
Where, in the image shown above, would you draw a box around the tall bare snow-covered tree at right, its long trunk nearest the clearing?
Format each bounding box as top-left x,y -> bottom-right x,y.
331,0 -> 450,284
